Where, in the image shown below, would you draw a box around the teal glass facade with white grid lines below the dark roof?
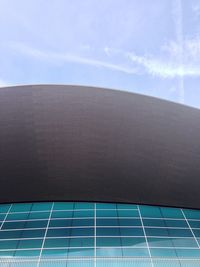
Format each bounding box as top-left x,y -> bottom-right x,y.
0,202 -> 200,267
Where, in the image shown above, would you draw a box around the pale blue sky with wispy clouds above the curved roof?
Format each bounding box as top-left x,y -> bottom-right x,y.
0,0 -> 200,108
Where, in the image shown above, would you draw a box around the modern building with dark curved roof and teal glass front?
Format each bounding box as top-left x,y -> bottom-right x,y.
0,85 -> 200,267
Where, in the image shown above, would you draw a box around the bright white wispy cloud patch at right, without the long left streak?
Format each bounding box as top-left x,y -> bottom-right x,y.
105,38 -> 200,79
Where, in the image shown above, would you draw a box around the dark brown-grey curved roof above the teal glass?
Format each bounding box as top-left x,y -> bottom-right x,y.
0,85 -> 200,208
